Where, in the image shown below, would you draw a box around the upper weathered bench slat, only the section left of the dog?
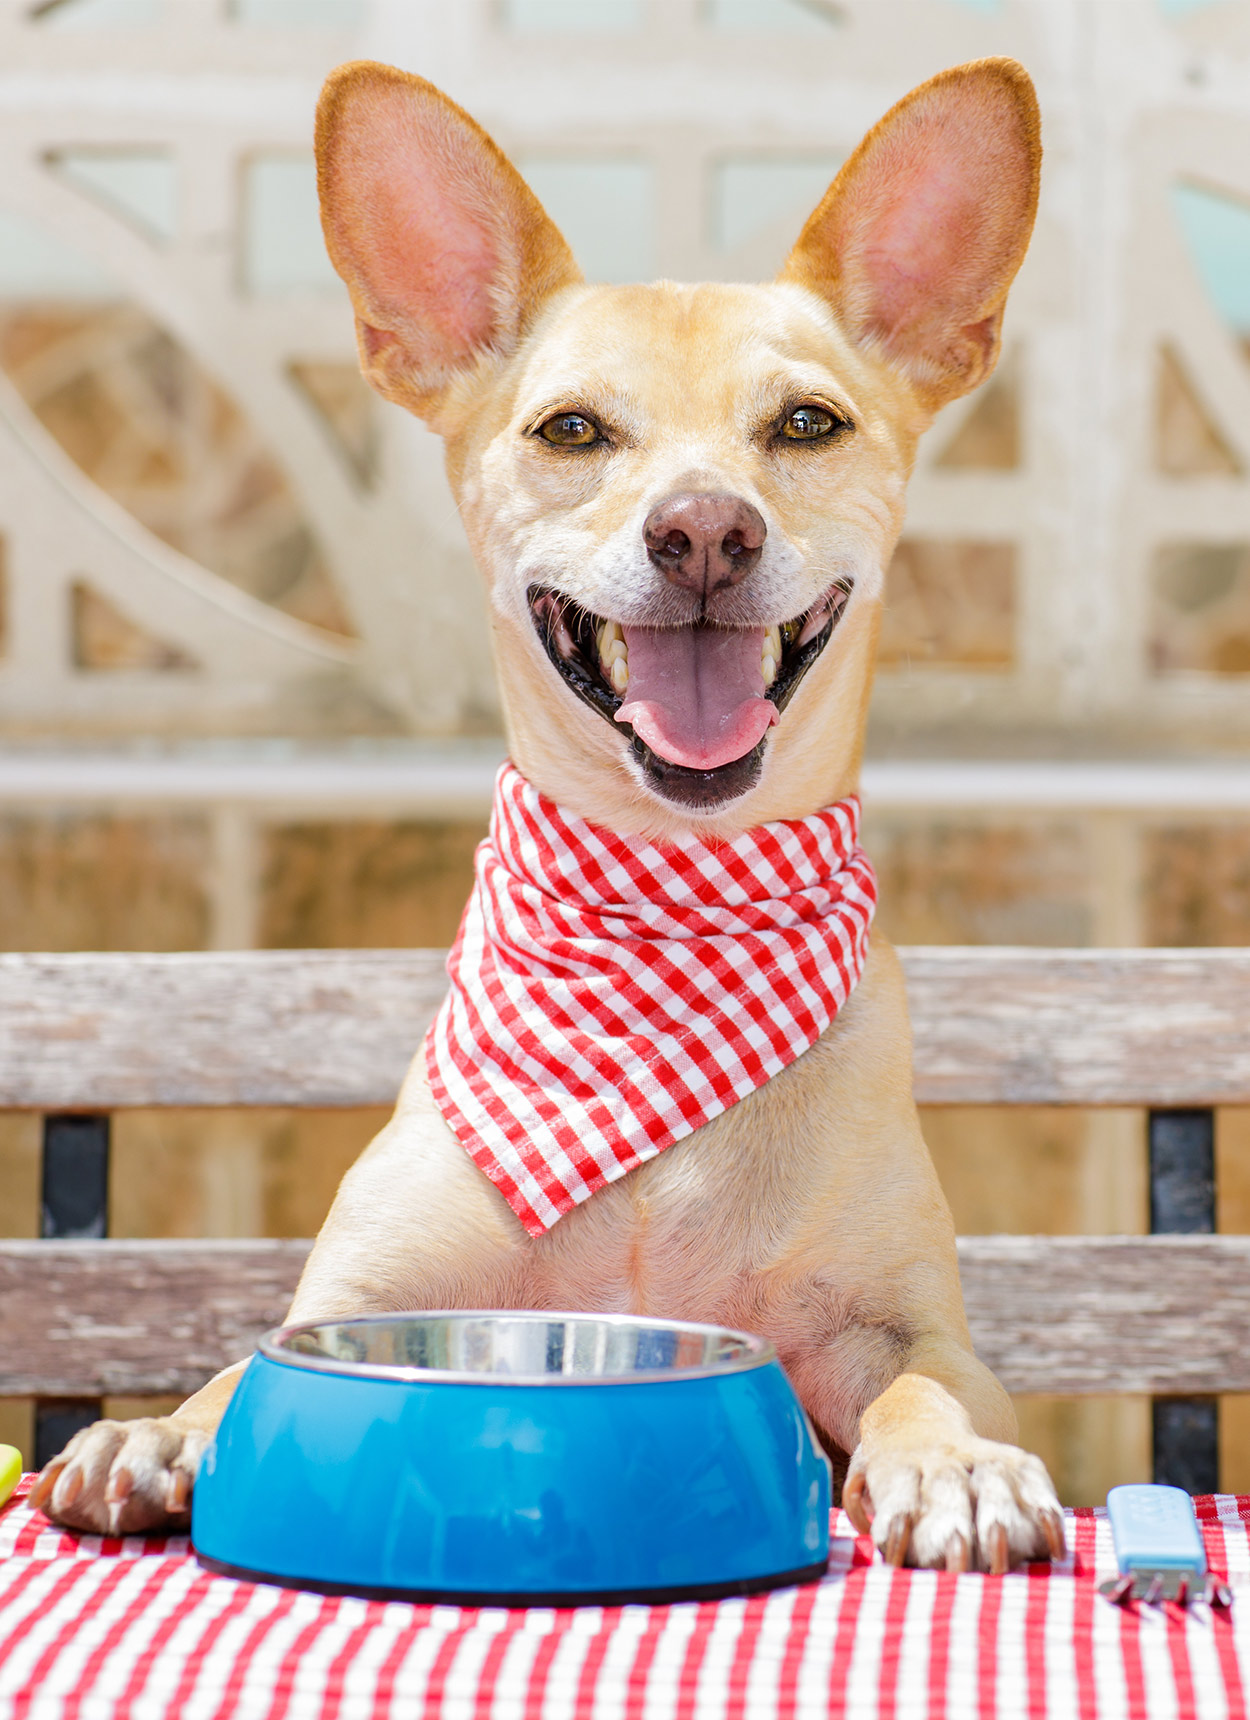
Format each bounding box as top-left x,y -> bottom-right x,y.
0,949 -> 447,1111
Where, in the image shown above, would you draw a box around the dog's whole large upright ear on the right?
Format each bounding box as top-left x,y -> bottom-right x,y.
781,60 -> 1042,408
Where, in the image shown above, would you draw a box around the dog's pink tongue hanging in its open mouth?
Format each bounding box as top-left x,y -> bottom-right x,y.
616,626 -> 777,771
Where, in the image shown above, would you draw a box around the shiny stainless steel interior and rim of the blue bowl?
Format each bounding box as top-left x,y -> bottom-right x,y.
260,1312 -> 775,1385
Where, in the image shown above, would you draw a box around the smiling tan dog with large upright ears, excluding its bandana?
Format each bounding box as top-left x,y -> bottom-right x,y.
33,60 -> 1064,1570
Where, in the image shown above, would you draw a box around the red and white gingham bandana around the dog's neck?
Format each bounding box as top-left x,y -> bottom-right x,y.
426,765 -> 877,1237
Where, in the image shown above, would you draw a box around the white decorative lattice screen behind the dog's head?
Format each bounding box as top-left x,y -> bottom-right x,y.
0,0 -> 1250,745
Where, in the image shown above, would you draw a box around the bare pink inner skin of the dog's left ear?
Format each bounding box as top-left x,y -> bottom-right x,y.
325,91 -> 507,368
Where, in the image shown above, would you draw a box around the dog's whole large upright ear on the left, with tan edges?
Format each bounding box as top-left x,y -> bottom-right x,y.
316,60 -> 581,418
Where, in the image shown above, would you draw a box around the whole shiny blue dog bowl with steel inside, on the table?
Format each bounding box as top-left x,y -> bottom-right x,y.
191,1312 -> 829,1605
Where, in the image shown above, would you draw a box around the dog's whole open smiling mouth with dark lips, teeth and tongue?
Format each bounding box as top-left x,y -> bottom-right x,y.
528,580 -> 851,808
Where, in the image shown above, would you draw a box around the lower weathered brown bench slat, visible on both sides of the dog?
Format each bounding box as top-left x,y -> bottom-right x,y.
0,1237 -> 1250,1397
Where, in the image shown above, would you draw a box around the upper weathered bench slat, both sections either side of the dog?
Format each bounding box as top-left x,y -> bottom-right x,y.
0,946 -> 1250,1111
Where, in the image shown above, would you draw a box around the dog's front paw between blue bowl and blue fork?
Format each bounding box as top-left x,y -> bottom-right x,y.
843,1440 -> 1064,1576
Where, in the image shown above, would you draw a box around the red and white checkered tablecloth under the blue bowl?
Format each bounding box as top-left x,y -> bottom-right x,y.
0,1484 -> 1250,1720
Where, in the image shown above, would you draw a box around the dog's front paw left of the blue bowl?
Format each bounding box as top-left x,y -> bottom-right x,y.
31,1416 -> 210,1534
